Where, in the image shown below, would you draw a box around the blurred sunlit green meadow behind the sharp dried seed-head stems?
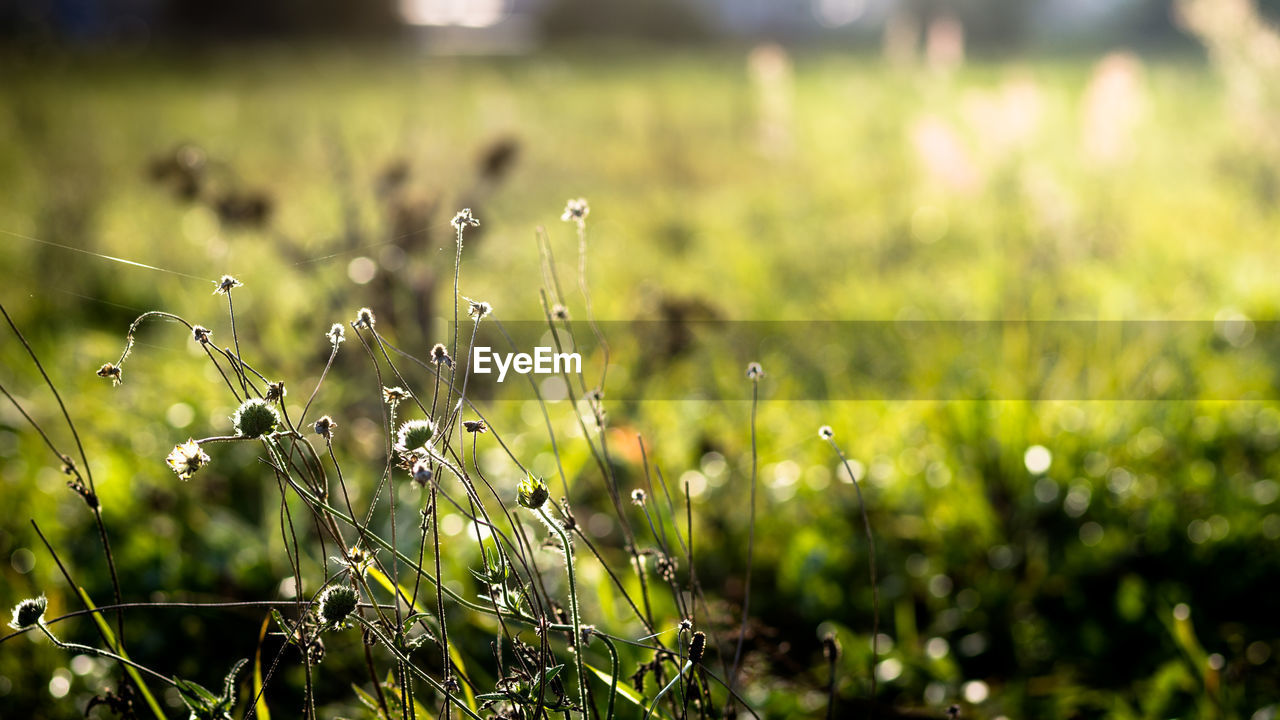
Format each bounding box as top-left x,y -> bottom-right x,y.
0,40 -> 1280,719
